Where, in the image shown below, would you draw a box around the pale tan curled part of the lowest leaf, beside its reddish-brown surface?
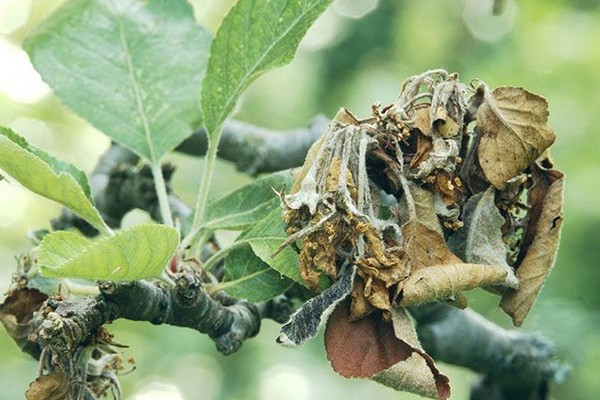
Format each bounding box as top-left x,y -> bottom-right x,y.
371,307 -> 450,399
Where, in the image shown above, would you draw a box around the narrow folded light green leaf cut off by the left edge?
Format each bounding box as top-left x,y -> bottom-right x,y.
0,126 -> 110,232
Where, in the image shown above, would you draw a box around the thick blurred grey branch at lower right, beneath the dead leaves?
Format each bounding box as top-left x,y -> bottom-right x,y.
410,303 -> 567,400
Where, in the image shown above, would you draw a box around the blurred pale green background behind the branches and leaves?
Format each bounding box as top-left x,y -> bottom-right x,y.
0,0 -> 600,400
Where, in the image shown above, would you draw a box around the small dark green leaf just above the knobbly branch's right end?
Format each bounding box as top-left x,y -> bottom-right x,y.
220,245 -> 292,303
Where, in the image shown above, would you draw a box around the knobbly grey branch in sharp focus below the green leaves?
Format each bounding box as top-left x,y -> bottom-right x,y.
39,270 -> 261,354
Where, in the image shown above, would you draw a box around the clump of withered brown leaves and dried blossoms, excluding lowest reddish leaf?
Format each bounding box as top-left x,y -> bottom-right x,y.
281,70 -> 564,398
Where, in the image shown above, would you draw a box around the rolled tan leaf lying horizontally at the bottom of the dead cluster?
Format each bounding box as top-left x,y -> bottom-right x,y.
397,263 -> 506,307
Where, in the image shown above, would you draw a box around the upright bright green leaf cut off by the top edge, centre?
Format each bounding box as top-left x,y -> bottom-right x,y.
202,0 -> 333,135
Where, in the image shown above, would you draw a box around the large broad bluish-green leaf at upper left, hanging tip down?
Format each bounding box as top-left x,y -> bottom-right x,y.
24,0 -> 210,163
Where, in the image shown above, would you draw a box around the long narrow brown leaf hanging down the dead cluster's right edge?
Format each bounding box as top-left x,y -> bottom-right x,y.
500,167 -> 564,326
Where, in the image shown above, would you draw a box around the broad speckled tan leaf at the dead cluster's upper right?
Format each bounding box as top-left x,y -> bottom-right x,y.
477,86 -> 555,189
